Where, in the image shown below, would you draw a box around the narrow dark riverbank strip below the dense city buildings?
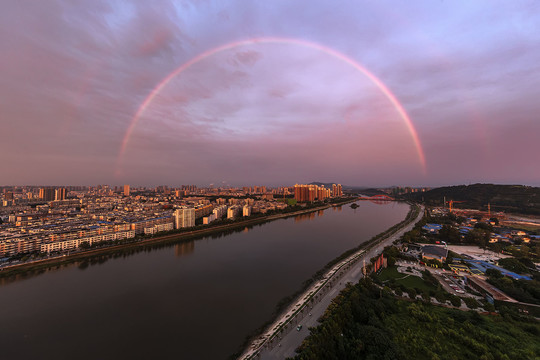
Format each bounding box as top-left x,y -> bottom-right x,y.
0,198 -> 356,278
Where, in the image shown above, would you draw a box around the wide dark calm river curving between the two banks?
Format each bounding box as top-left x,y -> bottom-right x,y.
0,201 -> 409,359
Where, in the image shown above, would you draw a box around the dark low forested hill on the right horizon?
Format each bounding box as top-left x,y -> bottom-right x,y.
401,184 -> 540,215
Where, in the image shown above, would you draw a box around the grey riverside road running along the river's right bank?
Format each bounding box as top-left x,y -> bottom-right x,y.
254,208 -> 424,360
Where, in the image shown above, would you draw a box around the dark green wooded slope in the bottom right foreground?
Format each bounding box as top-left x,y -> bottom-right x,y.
294,278 -> 540,360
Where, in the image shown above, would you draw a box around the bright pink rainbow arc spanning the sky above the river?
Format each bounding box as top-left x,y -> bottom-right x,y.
118,37 -> 426,173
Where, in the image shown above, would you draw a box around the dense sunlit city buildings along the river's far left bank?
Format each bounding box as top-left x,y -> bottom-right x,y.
0,185 -> 341,259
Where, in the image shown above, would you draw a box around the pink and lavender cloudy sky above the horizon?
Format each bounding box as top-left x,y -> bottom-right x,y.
0,0 -> 540,186
